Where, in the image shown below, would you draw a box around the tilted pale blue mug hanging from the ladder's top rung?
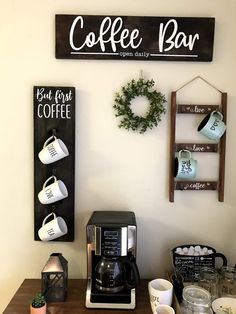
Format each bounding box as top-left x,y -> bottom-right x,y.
197,110 -> 226,141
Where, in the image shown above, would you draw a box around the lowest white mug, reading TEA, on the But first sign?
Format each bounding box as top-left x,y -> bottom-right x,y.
38,213 -> 68,241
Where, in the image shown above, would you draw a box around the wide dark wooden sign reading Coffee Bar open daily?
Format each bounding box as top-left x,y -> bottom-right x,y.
56,14 -> 215,62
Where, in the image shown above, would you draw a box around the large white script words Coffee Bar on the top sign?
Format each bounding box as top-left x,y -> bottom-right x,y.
69,16 -> 200,53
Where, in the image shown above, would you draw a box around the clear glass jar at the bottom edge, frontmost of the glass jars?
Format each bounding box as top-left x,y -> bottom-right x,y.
181,285 -> 211,314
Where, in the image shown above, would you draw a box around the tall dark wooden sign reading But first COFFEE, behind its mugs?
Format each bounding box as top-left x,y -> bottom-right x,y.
34,86 -> 75,241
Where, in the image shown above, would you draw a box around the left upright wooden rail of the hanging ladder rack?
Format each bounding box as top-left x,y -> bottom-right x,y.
169,92 -> 176,202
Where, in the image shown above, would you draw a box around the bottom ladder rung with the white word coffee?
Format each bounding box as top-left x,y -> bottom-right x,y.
175,181 -> 218,191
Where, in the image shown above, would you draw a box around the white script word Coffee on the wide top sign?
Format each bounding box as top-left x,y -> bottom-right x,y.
69,16 -> 142,52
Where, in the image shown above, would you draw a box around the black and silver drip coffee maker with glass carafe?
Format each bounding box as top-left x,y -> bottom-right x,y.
86,211 -> 139,309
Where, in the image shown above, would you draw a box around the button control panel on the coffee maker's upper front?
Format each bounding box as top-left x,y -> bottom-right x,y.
95,227 -> 127,257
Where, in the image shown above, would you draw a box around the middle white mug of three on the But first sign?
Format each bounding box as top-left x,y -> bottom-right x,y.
38,176 -> 68,204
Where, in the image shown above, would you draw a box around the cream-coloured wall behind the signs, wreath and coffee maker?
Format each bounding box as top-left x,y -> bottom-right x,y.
0,0 -> 236,311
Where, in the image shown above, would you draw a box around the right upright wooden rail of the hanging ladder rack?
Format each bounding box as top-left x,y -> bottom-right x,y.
218,93 -> 227,202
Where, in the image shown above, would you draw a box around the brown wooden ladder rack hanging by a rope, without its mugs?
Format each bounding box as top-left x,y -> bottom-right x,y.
169,76 -> 227,202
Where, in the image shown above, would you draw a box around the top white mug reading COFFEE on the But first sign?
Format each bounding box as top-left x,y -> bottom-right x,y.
38,135 -> 69,164
